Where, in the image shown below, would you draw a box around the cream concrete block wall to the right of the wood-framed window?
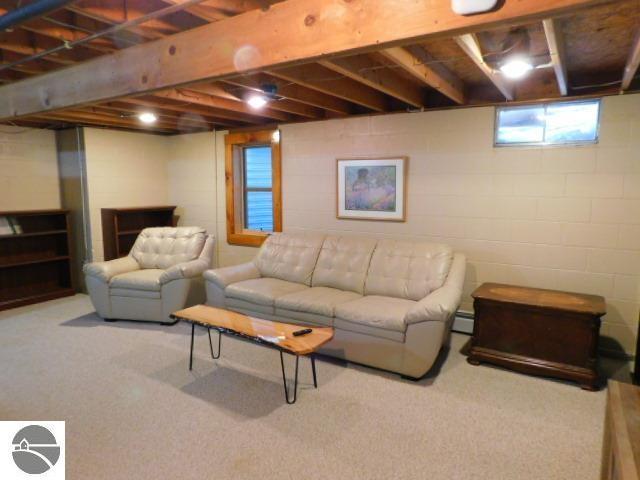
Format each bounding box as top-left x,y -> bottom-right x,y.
280,95 -> 640,353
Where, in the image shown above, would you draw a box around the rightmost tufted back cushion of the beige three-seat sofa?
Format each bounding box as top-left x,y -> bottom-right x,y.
365,240 -> 453,301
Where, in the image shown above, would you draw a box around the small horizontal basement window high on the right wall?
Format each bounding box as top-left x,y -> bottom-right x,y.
494,100 -> 600,147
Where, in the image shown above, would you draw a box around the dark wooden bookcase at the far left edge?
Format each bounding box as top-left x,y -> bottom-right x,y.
0,210 -> 75,310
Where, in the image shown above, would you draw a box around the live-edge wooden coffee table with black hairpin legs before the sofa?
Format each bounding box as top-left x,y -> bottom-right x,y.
171,305 -> 333,404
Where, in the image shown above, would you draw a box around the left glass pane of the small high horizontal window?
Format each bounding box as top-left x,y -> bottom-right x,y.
496,105 -> 544,143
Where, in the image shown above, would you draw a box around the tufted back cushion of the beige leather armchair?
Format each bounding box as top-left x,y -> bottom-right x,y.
131,227 -> 206,270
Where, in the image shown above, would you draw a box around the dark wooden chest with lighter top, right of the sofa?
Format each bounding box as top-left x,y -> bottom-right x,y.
467,283 -> 606,390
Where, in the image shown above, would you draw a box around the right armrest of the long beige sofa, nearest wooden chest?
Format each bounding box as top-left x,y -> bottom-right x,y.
405,253 -> 466,325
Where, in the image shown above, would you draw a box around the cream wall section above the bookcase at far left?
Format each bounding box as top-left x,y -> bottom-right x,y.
0,125 -> 60,210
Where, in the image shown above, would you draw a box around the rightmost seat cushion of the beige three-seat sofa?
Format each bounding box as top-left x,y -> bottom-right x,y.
335,295 -> 417,332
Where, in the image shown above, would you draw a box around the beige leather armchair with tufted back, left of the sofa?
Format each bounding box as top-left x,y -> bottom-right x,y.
84,227 -> 214,323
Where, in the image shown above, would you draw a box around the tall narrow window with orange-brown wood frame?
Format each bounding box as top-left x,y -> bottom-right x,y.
225,130 -> 282,247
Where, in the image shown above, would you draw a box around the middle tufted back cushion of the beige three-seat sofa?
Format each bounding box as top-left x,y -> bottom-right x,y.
312,236 -> 376,295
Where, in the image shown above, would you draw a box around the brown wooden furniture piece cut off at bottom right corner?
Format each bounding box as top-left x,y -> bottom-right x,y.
600,380 -> 640,480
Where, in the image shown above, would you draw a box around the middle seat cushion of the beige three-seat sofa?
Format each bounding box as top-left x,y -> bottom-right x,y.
276,287 -> 362,317
